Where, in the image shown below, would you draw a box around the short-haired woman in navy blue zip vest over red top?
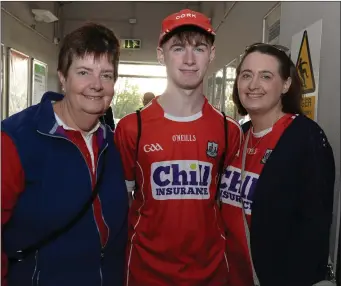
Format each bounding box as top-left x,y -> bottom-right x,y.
1,24 -> 128,286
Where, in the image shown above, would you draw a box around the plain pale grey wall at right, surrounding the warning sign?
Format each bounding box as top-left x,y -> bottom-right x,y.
280,2 -> 341,266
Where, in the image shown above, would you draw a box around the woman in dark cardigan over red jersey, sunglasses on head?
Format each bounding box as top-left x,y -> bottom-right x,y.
221,44 -> 335,286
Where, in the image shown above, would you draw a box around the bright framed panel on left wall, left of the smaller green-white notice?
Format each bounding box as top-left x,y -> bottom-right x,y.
8,49 -> 29,116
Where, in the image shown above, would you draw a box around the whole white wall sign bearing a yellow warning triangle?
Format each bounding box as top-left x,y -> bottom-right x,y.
291,19 -> 322,121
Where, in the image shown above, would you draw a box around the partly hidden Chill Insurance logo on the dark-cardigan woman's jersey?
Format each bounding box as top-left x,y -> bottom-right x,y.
220,166 -> 259,214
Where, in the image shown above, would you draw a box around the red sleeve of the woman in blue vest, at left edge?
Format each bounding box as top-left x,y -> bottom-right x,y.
1,132 -> 25,285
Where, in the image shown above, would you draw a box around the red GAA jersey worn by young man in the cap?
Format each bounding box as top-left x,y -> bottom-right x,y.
115,99 -> 242,286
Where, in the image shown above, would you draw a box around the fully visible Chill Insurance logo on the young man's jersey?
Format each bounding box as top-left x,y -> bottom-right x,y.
151,160 -> 212,200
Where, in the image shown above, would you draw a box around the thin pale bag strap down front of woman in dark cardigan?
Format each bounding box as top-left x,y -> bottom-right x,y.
239,130 -> 260,286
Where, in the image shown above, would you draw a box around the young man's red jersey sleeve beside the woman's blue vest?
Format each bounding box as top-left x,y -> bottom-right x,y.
114,114 -> 137,192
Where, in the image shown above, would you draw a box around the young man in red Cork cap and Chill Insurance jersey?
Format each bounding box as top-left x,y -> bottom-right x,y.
115,10 -> 242,286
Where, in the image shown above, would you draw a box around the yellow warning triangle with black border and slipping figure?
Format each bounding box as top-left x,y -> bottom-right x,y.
296,31 -> 315,94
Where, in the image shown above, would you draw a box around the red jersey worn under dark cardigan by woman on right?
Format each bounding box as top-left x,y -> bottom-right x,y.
220,114 -> 295,286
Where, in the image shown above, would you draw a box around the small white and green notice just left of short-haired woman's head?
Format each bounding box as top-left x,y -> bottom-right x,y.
32,59 -> 47,104
